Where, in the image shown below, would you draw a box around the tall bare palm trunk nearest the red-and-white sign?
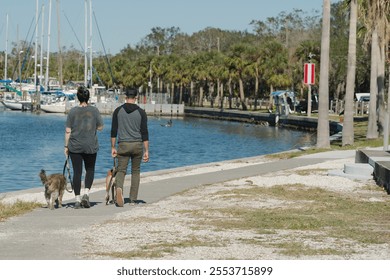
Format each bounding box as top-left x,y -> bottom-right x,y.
316,0 -> 330,148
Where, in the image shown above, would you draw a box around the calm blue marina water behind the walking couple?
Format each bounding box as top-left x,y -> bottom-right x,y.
0,109 -> 316,193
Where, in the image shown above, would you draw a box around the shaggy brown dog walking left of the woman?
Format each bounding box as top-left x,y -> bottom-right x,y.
39,169 -> 66,210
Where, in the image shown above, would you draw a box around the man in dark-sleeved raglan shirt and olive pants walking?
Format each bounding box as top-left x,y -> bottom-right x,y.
111,88 -> 149,207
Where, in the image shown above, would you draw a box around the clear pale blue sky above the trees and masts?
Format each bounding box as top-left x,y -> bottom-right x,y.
0,0 -> 339,55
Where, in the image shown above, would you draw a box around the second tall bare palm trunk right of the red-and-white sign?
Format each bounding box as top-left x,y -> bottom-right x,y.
342,0 -> 358,146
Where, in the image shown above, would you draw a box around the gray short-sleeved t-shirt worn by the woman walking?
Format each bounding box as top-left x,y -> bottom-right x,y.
66,106 -> 103,154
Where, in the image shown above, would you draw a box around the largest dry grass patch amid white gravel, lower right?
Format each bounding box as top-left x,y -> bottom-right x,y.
181,184 -> 390,256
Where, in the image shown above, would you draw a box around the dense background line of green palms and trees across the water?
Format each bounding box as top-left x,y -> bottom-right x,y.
0,2 -> 369,106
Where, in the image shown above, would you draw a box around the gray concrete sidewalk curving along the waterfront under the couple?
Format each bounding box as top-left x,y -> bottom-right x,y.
0,151 -> 355,260
